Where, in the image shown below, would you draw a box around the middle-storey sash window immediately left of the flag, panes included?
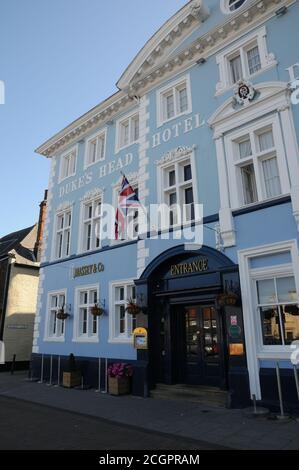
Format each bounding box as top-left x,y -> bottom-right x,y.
80,196 -> 102,252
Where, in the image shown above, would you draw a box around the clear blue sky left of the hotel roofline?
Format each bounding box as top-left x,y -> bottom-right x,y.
0,0 -> 187,237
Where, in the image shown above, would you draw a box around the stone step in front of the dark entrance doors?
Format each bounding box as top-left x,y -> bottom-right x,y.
151,384 -> 227,407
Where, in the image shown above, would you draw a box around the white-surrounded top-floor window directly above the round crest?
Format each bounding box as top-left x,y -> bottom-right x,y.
216,26 -> 277,95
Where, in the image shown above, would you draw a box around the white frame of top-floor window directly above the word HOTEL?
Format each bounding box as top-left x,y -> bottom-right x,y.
156,73 -> 192,128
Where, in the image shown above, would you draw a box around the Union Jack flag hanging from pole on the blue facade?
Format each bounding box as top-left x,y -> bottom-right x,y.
115,175 -> 140,240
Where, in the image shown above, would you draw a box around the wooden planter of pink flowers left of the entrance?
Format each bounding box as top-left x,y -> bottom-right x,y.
108,362 -> 133,395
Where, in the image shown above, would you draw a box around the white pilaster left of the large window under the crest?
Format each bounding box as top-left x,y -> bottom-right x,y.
214,134 -> 236,248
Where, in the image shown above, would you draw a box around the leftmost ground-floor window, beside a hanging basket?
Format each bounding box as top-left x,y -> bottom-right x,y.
46,291 -> 66,340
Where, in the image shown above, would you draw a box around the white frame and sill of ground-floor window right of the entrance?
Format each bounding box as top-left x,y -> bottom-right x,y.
238,239 -> 299,400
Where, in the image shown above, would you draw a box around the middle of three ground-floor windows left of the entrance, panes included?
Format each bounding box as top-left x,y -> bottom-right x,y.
76,285 -> 99,340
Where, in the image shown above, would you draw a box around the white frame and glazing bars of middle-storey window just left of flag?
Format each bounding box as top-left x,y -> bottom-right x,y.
78,191 -> 104,254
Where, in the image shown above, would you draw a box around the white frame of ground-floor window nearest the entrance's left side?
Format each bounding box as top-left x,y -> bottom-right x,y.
108,279 -> 135,344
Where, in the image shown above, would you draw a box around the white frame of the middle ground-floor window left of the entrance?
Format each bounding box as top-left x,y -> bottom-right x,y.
72,284 -> 100,343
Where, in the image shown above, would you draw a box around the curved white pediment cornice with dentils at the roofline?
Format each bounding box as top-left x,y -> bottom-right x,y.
117,0 -> 209,93
